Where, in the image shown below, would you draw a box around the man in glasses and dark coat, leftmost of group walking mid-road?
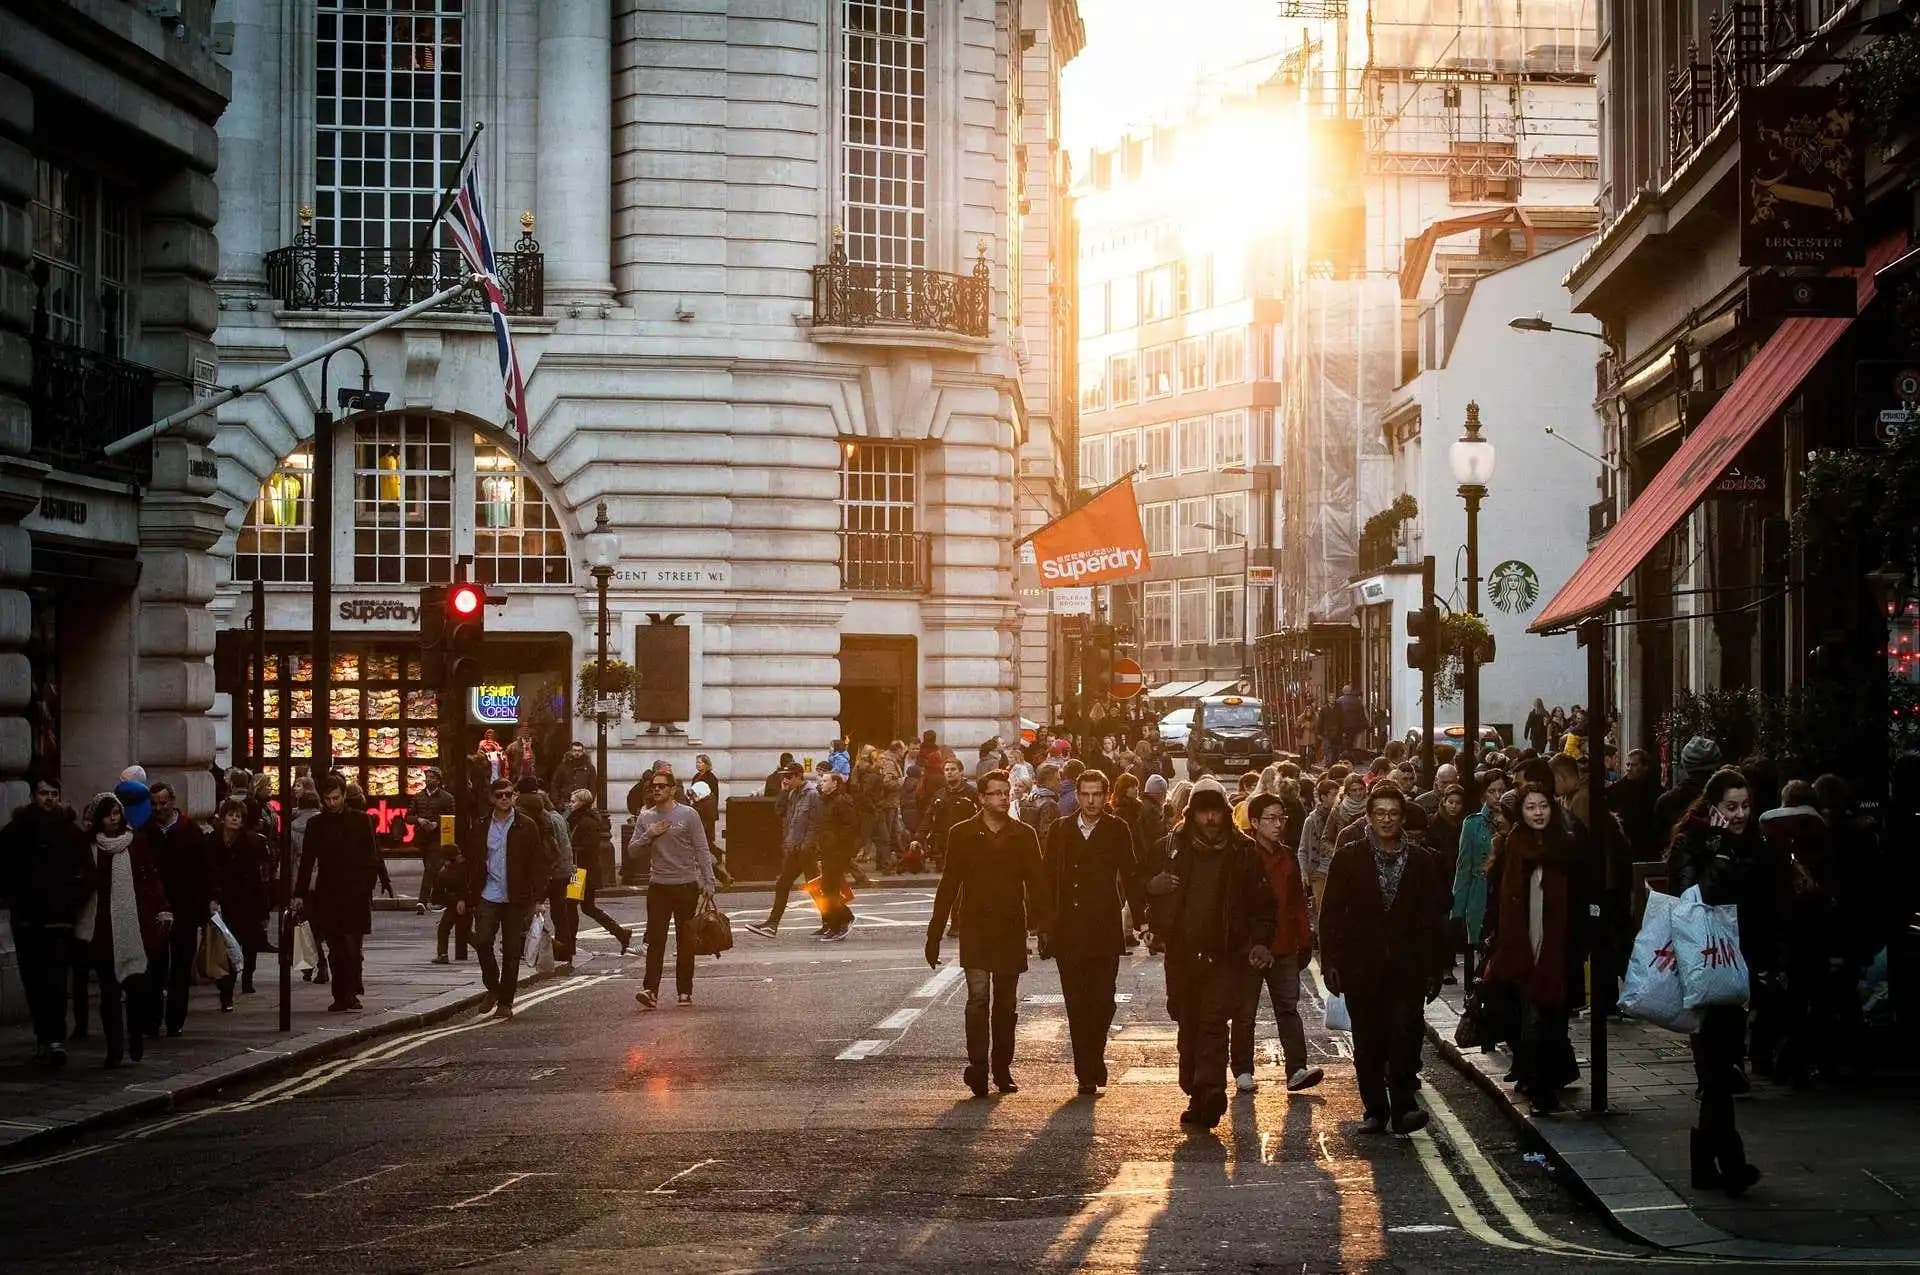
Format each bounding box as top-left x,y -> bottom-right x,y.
927,770 -> 1052,1098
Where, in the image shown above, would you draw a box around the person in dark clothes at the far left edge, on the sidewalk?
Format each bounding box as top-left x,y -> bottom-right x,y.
0,778 -> 94,1068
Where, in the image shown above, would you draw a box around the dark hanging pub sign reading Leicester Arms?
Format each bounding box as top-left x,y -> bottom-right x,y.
1740,83 -> 1866,267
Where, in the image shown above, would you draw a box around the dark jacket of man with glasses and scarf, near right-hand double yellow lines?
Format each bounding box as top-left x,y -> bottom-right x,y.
1319,833 -> 1453,998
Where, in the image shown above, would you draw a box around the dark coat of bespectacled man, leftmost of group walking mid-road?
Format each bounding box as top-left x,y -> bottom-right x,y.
929,817 -> 1052,974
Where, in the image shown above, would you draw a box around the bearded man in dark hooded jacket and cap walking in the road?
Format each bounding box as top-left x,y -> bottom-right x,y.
1146,785 -> 1277,1129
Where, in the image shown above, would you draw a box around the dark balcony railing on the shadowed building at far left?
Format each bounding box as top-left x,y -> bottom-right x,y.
27,336 -> 154,484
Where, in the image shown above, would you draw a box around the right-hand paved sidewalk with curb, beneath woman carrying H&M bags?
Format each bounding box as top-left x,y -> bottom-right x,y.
1427,987 -> 1920,1262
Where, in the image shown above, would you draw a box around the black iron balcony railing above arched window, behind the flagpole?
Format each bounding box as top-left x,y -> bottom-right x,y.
267,209 -> 545,315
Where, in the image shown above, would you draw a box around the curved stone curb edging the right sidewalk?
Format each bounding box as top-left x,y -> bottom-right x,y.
1425,1000 -> 1920,1263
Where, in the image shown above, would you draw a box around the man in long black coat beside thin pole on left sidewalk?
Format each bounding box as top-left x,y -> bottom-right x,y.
293,772 -> 382,1014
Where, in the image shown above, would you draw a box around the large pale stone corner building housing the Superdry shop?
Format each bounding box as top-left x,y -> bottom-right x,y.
207,0 -> 1085,841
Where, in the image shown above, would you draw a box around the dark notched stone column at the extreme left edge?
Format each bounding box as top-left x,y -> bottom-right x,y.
0,75 -> 46,810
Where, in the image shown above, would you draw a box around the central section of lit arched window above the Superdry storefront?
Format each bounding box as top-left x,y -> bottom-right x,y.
353,413 -> 453,584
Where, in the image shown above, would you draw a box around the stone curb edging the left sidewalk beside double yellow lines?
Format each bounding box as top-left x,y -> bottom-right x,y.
0,974 -> 557,1162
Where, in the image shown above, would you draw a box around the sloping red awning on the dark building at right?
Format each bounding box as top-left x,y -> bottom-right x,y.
1526,232 -> 1907,634
